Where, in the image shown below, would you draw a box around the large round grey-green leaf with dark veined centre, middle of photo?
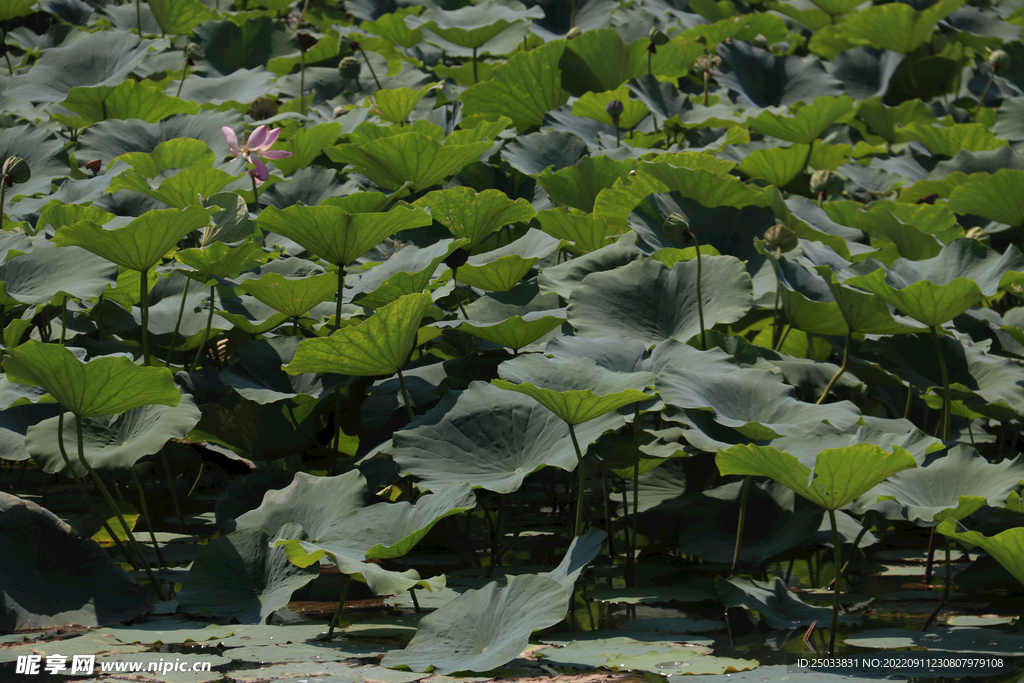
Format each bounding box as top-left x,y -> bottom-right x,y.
391,382 -> 624,494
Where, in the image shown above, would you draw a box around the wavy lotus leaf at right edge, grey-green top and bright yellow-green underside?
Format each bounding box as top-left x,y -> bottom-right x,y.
838,239 -> 1024,327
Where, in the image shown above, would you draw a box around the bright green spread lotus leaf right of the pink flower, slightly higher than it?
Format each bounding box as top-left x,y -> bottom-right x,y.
324,133 -> 494,189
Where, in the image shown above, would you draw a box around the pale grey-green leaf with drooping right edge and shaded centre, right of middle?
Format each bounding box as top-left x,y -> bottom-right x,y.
657,367 -> 860,440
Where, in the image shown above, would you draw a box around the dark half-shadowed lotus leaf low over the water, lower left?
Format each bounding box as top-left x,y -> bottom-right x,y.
177,528 -> 319,624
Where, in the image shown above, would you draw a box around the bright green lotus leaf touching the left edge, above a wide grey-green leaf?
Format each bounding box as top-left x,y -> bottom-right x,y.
3,340 -> 181,418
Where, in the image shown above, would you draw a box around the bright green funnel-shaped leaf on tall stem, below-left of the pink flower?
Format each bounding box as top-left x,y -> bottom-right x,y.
53,206 -> 215,272
